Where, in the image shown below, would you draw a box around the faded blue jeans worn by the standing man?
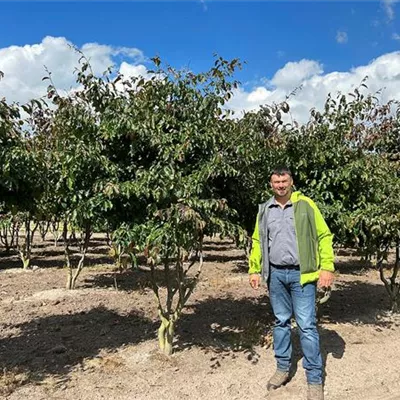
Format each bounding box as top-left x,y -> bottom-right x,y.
269,267 -> 322,384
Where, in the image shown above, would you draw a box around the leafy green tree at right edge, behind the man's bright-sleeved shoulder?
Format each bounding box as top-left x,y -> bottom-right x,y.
285,85 -> 400,311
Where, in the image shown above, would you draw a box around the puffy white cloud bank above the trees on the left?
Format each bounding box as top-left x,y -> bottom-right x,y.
0,36 -> 147,103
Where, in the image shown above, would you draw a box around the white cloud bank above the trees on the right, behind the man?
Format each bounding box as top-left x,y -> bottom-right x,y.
228,52 -> 400,123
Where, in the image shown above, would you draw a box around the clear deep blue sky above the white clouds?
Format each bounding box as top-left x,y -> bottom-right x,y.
0,0 -> 400,121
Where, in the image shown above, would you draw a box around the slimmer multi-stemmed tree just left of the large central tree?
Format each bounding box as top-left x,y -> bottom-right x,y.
35,62 -> 114,289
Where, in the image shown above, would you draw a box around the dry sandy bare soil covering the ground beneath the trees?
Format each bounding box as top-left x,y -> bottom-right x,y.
0,238 -> 400,400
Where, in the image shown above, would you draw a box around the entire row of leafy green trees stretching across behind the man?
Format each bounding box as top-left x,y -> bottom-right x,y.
0,57 -> 400,353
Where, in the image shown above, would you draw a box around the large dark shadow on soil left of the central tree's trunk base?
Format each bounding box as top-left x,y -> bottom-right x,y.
0,307 -> 158,380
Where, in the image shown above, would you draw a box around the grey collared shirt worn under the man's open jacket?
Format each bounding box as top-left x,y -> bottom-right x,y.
267,199 -> 299,265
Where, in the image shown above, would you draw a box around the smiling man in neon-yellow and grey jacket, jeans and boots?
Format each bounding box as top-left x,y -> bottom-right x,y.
249,166 -> 334,400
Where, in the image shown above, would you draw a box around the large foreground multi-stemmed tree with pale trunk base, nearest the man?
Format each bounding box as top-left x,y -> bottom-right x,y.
95,58 -> 244,354
